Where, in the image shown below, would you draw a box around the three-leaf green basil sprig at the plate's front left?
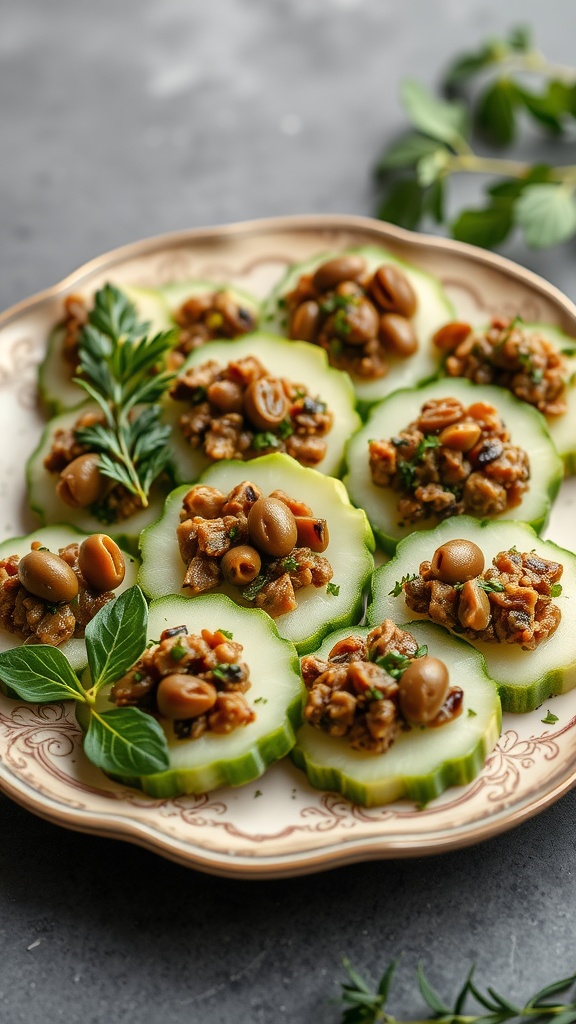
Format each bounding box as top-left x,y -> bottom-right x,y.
0,587 -> 169,775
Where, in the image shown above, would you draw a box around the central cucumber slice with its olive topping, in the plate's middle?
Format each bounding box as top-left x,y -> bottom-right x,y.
138,455 -> 374,653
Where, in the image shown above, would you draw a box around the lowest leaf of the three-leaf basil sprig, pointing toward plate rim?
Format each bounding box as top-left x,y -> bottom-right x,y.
84,708 -> 170,775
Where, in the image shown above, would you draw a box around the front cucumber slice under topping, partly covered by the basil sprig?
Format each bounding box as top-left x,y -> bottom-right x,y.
77,594 -> 303,799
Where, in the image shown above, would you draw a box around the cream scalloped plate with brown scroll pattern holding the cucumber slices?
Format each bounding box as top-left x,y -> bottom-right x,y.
0,209 -> 576,878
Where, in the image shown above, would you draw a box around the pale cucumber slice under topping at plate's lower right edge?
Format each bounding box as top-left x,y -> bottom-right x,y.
367,516 -> 576,713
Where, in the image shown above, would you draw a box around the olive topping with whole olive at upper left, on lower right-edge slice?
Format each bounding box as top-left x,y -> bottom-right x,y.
402,538 -> 564,650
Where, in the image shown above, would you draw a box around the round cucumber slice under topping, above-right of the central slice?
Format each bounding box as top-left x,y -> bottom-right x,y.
344,377 -> 563,554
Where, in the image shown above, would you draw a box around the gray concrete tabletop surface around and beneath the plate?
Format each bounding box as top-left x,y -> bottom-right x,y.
0,0 -> 576,1024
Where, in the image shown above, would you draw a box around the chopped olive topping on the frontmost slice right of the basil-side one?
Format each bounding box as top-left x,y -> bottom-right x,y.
301,620 -> 463,754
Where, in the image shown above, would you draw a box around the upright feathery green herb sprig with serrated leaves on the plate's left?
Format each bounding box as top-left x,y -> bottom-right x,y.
75,285 -> 174,508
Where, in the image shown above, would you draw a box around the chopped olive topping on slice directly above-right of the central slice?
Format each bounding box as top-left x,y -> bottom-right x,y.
369,396 -> 530,523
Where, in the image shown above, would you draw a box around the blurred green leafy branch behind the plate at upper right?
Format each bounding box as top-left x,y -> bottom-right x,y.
376,29 -> 576,248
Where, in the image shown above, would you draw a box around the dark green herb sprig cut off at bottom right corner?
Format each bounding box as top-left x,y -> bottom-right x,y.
340,959 -> 576,1024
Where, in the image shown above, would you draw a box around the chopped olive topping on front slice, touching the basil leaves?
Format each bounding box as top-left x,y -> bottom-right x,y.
110,626 -> 256,739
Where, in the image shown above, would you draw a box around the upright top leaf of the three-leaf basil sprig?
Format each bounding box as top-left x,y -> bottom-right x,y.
86,587 -> 148,691
